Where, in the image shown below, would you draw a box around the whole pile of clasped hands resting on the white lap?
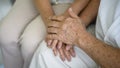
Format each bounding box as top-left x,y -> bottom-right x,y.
46,8 -> 85,61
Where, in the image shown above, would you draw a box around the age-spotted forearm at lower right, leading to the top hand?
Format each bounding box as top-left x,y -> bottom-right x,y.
78,33 -> 120,68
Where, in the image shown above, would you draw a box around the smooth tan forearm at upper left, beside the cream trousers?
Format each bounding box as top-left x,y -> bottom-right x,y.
34,0 -> 54,24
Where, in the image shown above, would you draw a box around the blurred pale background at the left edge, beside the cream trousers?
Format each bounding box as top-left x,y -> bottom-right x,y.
0,0 -> 15,68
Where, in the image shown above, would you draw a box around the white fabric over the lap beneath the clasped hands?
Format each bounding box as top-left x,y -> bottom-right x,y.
30,41 -> 98,68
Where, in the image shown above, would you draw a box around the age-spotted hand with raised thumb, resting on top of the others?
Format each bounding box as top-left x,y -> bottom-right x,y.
47,8 -> 86,45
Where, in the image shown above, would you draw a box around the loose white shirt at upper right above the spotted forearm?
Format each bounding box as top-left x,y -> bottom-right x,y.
96,0 -> 120,47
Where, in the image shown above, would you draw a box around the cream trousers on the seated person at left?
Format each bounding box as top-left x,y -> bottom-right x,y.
0,0 -> 42,68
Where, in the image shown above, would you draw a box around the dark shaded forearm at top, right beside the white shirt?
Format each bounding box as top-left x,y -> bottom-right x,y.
79,0 -> 100,26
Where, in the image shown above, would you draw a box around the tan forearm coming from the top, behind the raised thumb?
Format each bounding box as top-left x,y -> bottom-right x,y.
64,0 -> 90,17
